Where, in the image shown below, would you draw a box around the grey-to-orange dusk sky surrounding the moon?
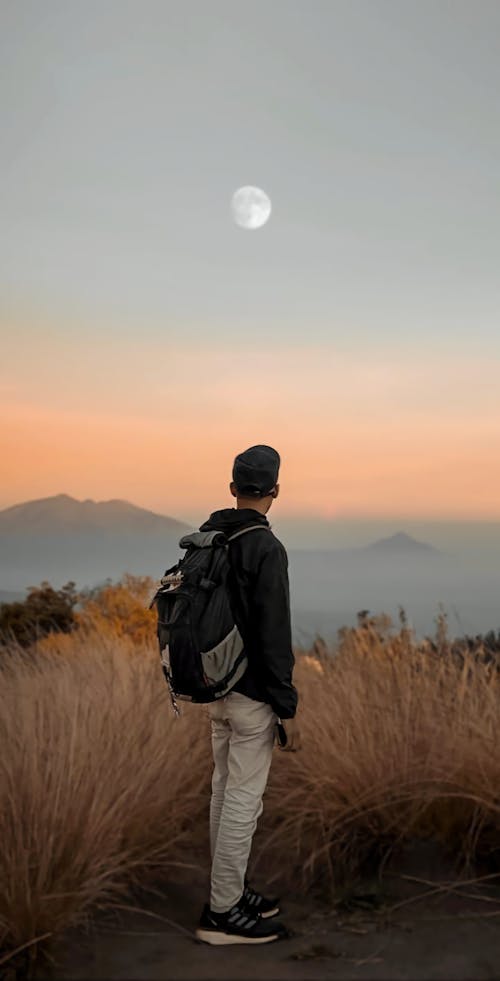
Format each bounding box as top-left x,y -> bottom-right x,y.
0,0 -> 500,530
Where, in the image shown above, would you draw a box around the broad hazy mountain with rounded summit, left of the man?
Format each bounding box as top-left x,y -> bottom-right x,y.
0,494 -> 193,592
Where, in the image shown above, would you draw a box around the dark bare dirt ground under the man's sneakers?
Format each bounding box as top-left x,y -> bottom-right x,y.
37,848 -> 500,981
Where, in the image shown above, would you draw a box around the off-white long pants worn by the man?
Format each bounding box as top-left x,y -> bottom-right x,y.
207,691 -> 278,913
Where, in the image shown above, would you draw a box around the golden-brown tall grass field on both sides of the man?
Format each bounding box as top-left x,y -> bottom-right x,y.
0,577 -> 500,967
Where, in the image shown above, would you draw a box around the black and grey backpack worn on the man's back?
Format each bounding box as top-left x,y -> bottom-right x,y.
149,525 -> 269,715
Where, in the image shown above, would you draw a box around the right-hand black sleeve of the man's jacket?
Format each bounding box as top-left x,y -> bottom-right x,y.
250,541 -> 298,719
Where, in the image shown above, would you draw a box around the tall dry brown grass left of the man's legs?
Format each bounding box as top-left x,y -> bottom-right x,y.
0,627 -> 209,963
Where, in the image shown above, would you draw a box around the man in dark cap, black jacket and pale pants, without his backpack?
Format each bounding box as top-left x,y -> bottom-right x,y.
196,445 -> 300,944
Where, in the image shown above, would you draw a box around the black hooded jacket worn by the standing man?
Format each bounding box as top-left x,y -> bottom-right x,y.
200,508 -> 297,719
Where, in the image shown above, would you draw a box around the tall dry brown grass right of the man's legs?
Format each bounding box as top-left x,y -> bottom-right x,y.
258,616 -> 500,890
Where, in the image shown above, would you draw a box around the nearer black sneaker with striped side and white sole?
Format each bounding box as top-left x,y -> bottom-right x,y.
196,897 -> 288,944
